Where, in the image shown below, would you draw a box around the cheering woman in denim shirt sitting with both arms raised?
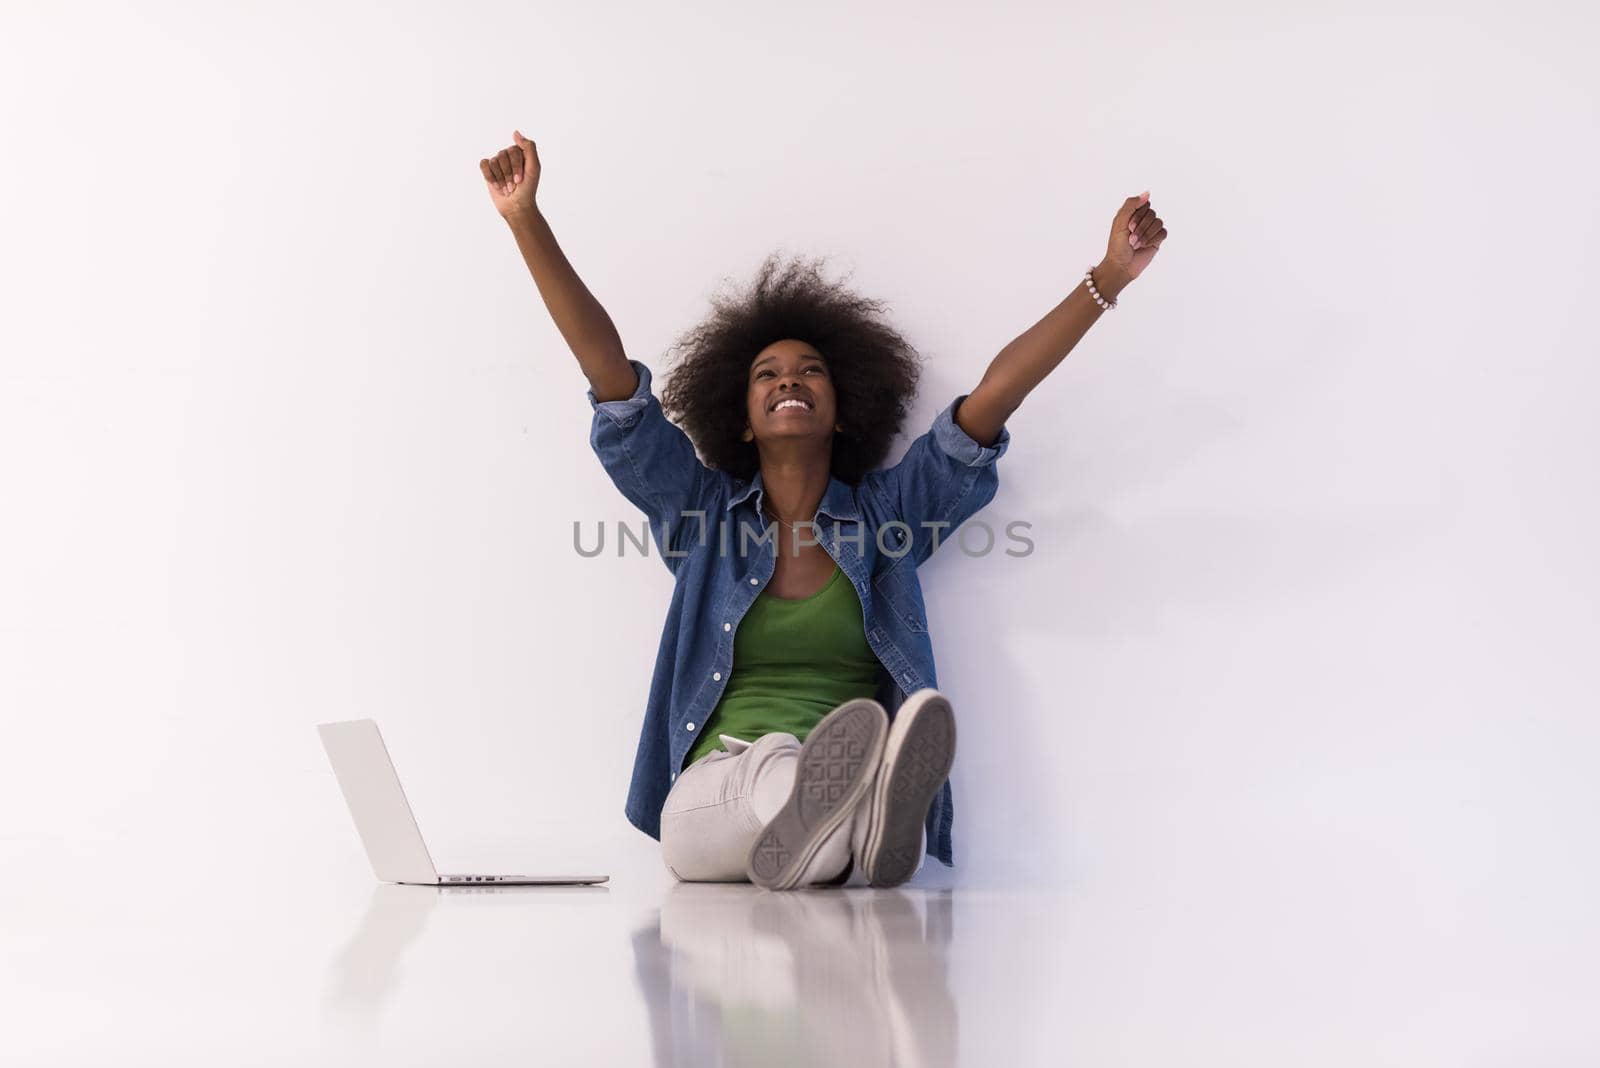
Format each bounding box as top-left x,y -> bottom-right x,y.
478,131 -> 1166,889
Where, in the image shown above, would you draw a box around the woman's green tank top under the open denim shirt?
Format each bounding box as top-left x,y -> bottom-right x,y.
683,566 -> 880,767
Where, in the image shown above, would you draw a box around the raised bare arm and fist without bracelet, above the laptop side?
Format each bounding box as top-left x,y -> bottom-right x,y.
478,131 -> 638,401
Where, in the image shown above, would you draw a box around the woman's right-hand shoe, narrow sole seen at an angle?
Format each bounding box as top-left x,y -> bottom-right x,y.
862,695 -> 955,886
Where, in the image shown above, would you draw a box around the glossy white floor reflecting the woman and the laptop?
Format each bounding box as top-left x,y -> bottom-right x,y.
0,844 -> 1600,1068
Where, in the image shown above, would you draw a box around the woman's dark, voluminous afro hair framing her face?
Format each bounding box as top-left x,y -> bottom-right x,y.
661,253 -> 922,486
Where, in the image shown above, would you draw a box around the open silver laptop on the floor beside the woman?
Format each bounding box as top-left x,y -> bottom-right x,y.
317,719 -> 611,886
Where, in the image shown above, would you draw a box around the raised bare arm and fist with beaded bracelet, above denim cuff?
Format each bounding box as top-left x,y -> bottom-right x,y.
955,192 -> 1166,446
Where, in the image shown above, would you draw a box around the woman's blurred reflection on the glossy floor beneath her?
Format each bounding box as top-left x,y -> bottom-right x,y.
634,883 -> 957,1068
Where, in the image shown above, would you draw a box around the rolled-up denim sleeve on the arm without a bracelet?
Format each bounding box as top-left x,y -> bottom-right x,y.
586,360 -> 715,571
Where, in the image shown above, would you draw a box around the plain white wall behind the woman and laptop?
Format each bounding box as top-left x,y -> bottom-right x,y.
0,2 -> 1600,1063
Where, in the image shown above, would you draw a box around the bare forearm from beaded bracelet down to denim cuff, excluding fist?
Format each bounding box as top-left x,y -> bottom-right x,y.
955,262 -> 1128,446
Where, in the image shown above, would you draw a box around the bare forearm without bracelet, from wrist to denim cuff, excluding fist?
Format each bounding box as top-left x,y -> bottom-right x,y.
506,208 -> 638,401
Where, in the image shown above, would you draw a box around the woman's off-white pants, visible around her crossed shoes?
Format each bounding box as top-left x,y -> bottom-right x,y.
661,732 -> 928,886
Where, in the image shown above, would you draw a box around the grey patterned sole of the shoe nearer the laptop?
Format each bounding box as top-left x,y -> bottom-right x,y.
746,697 -> 888,891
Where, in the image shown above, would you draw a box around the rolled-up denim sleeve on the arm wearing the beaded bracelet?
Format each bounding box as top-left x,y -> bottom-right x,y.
866,393 -> 1011,564
